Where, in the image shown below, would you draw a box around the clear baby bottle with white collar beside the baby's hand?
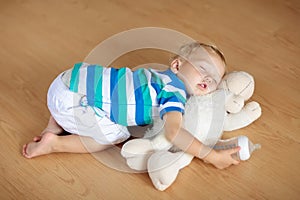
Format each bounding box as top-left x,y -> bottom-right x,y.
214,135 -> 261,161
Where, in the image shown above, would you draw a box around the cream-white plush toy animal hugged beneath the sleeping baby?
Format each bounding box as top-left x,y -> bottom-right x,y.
121,72 -> 261,190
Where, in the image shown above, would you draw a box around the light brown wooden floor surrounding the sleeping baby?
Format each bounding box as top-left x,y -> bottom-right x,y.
0,0 -> 300,200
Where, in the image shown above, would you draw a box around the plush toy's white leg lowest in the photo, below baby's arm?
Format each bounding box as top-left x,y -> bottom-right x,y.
148,151 -> 193,191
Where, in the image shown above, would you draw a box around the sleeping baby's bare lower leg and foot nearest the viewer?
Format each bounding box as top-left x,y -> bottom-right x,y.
23,132 -> 111,158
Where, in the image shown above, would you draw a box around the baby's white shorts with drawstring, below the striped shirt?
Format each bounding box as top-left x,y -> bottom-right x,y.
47,75 -> 130,145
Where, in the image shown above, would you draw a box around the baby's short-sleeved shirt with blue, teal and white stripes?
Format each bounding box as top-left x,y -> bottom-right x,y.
69,63 -> 186,126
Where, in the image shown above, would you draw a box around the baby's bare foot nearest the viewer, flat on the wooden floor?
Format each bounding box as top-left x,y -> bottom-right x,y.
23,132 -> 58,158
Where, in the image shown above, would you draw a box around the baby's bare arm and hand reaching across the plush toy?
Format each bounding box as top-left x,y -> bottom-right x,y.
164,111 -> 240,169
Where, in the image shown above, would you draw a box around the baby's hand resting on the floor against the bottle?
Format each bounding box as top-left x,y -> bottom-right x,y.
203,147 -> 241,169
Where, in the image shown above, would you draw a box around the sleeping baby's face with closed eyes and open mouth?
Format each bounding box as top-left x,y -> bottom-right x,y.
177,50 -> 225,96
